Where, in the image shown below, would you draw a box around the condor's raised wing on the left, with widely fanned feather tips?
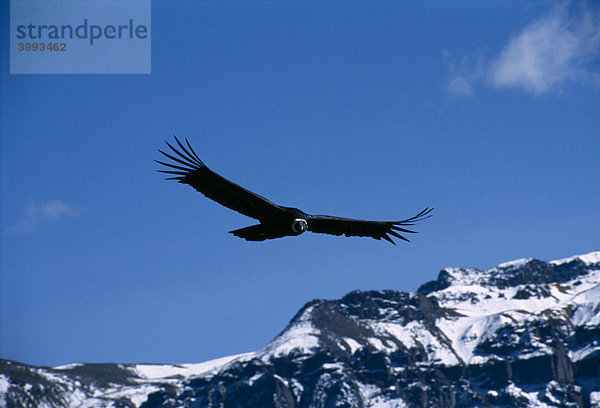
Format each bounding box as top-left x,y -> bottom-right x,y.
155,138 -> 283,220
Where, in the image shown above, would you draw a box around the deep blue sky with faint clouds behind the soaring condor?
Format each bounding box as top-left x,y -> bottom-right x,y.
0,0 -> 600,365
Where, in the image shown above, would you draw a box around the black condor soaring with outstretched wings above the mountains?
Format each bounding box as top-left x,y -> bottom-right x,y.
155,137 -> 433,245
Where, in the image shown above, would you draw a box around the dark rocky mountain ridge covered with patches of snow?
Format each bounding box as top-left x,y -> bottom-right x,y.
0,252 -> 600,408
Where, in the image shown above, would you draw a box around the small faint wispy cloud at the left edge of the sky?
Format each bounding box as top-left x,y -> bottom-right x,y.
8,200 -> 82,233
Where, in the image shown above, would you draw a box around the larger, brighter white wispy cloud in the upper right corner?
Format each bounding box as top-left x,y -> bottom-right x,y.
444,3 -> 600,96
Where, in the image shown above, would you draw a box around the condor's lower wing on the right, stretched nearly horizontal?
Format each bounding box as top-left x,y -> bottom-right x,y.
307,208 -> 433,245
